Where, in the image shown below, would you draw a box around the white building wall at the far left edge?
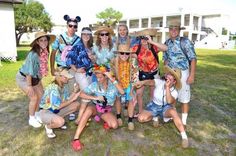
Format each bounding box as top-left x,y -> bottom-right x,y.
0,3 -> 17,61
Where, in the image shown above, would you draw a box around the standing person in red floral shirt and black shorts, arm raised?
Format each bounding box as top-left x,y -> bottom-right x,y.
132,29 -> 167,116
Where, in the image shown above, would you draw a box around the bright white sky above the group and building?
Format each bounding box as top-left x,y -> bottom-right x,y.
37,0 -> 236,32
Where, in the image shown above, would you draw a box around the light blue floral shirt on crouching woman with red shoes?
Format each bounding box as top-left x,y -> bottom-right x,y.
83,81 -> 118,106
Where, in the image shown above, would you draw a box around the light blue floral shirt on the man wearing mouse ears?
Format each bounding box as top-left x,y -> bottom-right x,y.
52,32 -> 81,67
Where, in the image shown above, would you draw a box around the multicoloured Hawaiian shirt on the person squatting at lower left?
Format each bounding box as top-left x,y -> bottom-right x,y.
39,83 -> 69,110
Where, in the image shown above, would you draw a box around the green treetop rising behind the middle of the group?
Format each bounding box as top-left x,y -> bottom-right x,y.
96,8 -> 123,26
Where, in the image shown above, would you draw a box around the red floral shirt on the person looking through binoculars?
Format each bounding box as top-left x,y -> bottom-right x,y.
132,45 -> 159,72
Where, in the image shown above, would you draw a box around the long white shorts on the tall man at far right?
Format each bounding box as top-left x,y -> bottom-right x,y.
178,69 -> 190,103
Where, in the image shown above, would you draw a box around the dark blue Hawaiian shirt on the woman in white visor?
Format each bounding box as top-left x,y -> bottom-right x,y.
66,42 -> 92,70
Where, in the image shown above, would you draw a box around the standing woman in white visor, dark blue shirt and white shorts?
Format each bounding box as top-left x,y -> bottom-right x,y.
66,27 -> 93,123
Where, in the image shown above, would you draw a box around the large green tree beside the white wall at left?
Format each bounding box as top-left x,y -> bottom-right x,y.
14,0 -> 53,45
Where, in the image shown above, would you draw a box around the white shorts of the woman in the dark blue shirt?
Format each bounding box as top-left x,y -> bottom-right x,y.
75,73 -> 92,103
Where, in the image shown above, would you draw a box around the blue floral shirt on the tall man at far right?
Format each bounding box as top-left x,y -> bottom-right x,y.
163,37 -> 197,70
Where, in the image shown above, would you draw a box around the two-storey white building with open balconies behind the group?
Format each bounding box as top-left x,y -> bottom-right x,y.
119,13 -> 234,49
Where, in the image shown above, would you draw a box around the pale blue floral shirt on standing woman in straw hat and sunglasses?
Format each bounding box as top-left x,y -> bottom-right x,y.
92,45 -> 116,68
